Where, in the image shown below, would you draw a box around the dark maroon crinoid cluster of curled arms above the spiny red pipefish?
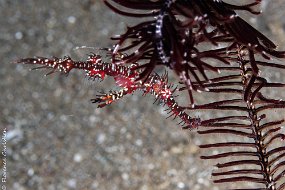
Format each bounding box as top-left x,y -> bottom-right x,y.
104,0 -> 284,106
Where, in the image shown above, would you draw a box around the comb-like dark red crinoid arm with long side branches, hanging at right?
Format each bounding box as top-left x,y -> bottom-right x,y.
189,46 -> 285,190
